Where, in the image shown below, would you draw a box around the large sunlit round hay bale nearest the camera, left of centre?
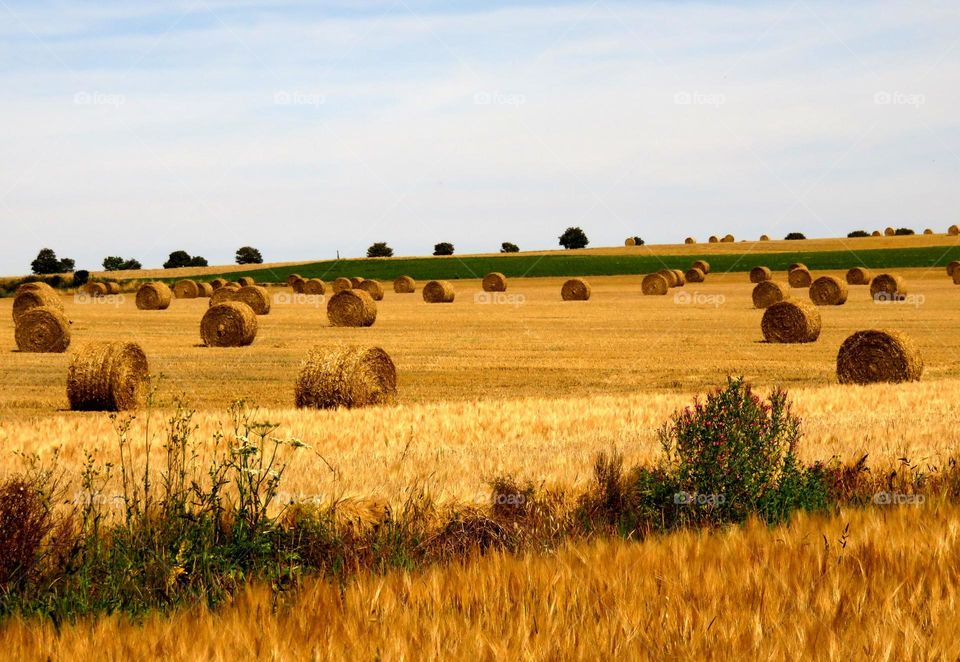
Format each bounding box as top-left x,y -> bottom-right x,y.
295,348 -> 397,409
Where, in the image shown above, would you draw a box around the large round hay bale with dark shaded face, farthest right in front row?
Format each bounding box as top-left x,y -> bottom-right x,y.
837,329 -> 923,384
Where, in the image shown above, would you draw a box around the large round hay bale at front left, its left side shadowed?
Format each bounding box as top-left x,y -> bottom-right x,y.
67,342 -> 149,411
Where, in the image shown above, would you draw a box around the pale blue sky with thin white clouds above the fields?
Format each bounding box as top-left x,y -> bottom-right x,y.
0,0 -> 960,274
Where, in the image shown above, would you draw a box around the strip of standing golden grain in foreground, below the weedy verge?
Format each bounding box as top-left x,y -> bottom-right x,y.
0,503 -> 960,661
